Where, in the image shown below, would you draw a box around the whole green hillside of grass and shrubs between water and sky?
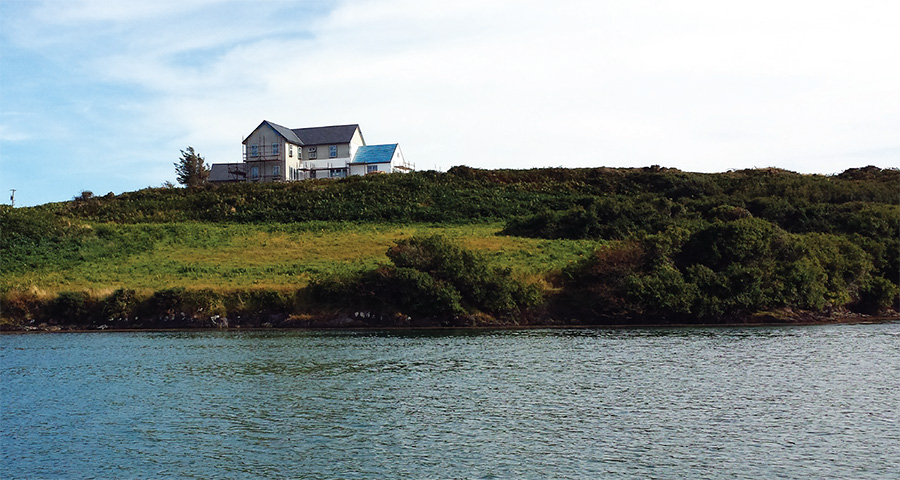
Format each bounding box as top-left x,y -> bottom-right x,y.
0,167 -> 900,331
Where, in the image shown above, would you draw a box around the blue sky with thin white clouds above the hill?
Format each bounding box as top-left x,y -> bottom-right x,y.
0,0 -> 900,205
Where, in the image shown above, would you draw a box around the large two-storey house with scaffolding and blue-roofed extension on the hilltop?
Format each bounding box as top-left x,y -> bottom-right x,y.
209,120 -> 413,182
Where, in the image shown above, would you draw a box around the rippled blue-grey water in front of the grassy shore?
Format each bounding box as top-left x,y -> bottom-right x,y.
0,323 -> 900,479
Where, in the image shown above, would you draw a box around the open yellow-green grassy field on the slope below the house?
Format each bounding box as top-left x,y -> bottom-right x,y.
0,222 -> 597,296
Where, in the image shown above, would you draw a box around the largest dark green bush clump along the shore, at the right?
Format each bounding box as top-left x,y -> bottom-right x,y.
560,217 -> 898,320
